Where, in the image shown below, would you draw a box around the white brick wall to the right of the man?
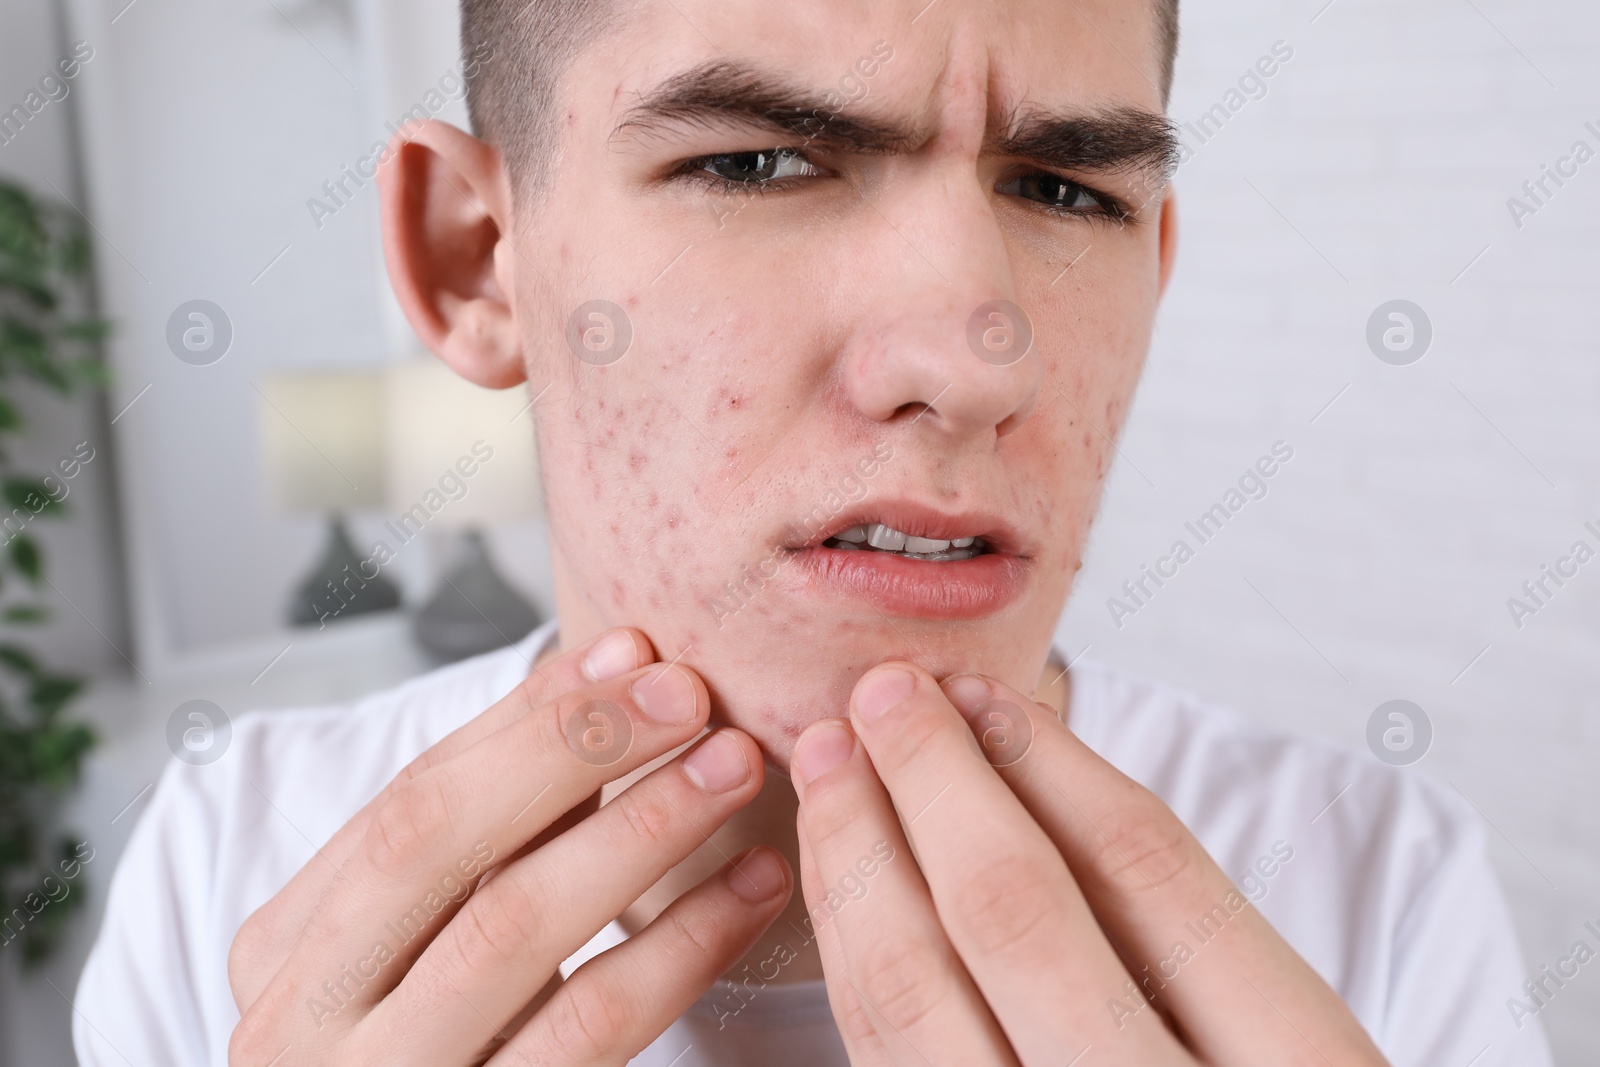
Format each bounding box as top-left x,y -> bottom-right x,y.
1062,0 -> 1600,1064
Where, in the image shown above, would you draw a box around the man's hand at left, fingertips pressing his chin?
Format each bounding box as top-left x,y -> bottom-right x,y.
229,629 -> 792,1067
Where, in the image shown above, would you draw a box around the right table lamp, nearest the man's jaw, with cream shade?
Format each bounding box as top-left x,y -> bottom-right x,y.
387,357 -> 541,661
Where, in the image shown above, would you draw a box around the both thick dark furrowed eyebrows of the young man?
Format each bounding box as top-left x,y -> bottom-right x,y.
611,59 -> 1178,184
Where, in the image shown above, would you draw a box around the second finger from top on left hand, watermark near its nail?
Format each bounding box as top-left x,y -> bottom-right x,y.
241,665 -> 710,1029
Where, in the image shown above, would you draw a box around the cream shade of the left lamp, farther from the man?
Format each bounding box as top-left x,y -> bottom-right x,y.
256,371 -> 387,514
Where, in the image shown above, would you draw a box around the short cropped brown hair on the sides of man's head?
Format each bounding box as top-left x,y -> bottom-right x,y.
461,0 -> 1179,189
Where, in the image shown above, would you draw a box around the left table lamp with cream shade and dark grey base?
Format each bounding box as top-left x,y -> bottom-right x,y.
256,371 -> 400,627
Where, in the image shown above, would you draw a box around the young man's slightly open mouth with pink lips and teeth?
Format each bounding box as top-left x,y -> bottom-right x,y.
784,501 -> 1030,621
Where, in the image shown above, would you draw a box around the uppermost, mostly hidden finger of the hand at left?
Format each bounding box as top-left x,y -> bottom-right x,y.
229,629 -> 656,1011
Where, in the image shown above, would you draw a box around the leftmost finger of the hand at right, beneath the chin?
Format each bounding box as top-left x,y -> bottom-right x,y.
792,720 -> 1016,1064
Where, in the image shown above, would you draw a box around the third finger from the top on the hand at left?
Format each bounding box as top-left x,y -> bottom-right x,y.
362,729 -> 763,1064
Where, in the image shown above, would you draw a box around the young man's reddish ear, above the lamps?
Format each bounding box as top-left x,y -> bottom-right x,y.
378,120 -> 528,389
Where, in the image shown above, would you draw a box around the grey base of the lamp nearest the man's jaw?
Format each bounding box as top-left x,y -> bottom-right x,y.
411,530 -> 542,661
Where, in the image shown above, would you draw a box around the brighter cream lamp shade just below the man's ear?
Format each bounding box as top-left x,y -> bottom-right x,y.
386,357 -> 541,530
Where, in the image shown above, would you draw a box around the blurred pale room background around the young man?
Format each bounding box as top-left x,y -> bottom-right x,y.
0,0 -> 1600,1067
